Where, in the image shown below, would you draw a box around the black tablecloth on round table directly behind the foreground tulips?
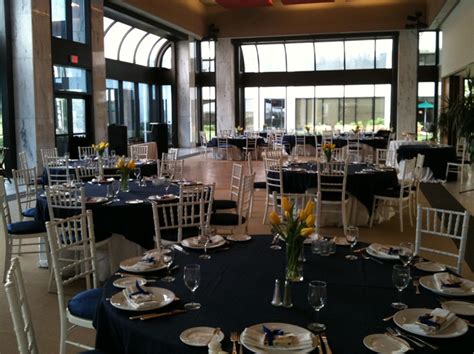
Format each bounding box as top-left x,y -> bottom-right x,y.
276,163 -> 398,214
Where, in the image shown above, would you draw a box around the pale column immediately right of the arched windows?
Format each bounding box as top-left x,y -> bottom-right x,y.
176,41 -> 198,147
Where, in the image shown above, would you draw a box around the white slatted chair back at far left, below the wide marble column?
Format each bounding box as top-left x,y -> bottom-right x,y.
12,167 -> 38,220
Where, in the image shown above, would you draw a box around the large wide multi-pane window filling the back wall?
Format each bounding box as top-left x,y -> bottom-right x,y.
234,33 -> 398,131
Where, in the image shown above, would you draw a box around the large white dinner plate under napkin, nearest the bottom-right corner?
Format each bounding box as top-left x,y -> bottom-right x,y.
393,308 -> 468,338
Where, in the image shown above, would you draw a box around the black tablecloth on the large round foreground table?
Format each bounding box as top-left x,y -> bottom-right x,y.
94,236 -> 474,354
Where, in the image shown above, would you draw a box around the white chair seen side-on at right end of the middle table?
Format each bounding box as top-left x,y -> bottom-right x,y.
370,158 -> 416,232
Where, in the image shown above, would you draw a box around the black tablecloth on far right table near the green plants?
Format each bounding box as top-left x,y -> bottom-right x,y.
397,145 -> 456,179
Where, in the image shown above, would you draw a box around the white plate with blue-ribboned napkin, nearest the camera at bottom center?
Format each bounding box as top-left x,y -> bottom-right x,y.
242,326 -> 313,350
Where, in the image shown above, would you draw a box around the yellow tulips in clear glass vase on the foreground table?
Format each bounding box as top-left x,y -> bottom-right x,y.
270,197 -> 315,282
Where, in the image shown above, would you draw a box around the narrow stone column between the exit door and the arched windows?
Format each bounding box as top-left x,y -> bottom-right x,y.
90,0 -> 107,142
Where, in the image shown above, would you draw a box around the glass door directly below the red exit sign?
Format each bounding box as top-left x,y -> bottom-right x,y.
54,95 -> 89,155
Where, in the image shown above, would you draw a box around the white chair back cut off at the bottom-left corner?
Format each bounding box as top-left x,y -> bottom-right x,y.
4,257 -> 38,354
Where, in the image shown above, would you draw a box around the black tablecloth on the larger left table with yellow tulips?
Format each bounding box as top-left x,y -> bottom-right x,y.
36,182 -> 179,249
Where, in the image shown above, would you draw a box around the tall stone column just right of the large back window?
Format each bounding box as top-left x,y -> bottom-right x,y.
397,29 -> 418,139
